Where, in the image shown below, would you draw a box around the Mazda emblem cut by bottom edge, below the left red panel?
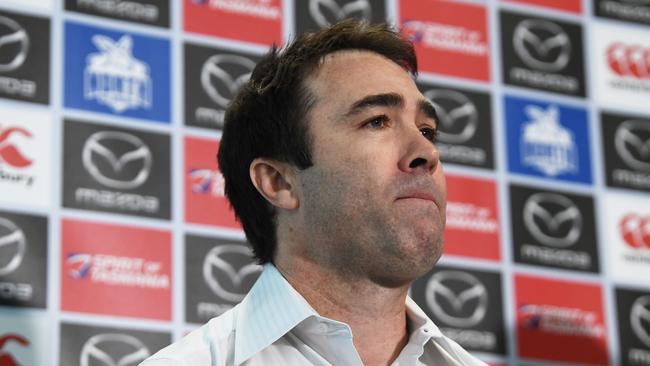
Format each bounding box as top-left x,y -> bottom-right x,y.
79,333 -> 151,366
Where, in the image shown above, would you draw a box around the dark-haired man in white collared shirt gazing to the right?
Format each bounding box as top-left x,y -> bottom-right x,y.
144,21 -> 484,366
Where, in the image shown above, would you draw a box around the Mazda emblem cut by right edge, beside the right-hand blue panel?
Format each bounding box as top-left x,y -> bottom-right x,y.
614,120 -> 650,172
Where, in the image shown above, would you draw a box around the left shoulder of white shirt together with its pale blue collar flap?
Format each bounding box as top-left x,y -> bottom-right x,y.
141,264 -> 315,366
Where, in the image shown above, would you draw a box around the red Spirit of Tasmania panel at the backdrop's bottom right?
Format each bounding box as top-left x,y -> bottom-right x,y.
515,274 -> 608,365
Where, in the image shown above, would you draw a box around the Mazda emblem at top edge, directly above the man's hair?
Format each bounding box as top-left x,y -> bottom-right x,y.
309,0 -> 372,28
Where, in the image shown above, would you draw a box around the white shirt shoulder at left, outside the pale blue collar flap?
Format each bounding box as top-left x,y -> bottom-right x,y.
139,306 -> 239,366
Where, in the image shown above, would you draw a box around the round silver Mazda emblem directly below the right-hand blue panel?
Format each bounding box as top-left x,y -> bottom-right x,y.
523,193 -> 582,247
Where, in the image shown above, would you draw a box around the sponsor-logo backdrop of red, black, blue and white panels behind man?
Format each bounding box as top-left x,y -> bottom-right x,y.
0,0 -> 650,366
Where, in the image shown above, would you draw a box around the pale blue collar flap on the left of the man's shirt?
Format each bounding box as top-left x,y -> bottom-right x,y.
235,263 -> 318,365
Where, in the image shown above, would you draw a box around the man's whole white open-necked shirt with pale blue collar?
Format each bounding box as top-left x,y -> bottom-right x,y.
140,264 -> 486,366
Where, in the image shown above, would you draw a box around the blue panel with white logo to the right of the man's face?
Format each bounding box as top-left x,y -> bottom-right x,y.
505,96 -> 592,184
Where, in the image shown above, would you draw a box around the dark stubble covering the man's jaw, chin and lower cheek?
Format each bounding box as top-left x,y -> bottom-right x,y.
294,163 -> 444,288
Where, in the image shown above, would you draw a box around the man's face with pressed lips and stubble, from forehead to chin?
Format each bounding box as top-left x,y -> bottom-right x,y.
298,50 -> 447,286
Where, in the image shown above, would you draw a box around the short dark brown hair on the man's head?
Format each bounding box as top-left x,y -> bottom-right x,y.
218,20 -> 417,263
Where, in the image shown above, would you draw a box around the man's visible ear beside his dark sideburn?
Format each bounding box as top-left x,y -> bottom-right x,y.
249,158 -> 300,210
